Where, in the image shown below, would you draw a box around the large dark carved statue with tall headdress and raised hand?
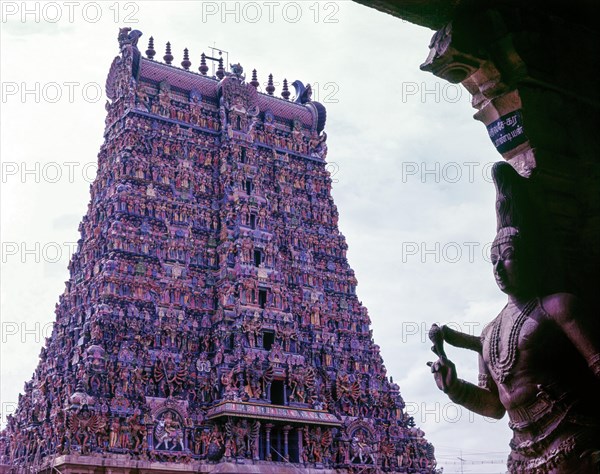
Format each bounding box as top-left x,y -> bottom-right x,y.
428,163 -> 600,474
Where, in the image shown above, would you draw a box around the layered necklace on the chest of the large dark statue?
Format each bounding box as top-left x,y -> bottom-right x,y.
488,299 -> 537,383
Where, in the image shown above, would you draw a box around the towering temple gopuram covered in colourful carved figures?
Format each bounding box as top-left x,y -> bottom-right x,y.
0,28 -> 435,474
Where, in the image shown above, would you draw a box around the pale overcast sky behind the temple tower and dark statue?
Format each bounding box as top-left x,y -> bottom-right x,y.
0,1 -> 510,473
